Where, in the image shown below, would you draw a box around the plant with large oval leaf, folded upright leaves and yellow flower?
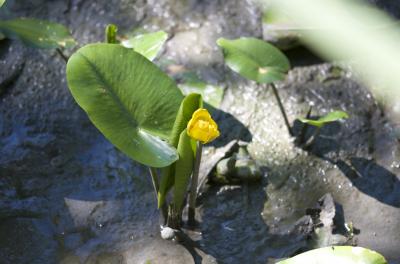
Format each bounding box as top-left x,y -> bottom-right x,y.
67,39 -> 219,231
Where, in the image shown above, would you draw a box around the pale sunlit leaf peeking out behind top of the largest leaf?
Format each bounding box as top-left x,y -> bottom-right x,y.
121,31 -> 168,61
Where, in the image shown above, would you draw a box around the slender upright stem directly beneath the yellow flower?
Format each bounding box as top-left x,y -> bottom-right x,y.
188,141 -> 203,226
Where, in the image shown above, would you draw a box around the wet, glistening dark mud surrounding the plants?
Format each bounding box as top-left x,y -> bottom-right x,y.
0,0 -> 400,263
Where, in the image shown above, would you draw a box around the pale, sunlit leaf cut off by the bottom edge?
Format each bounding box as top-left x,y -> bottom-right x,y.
277,246 -> 387,264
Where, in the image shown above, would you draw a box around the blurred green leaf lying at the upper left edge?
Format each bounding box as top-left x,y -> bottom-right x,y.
0,18 -> 76,49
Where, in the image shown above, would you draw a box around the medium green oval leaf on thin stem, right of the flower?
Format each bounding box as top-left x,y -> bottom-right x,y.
217,38 -> 290,83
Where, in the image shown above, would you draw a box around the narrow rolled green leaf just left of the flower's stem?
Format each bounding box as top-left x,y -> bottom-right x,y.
173,129 -> 194,212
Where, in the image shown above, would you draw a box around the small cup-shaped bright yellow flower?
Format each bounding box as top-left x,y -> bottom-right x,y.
187,108 -> 219,144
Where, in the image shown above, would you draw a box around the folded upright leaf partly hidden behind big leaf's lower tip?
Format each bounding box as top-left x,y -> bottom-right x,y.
158,94 -> 203,207
